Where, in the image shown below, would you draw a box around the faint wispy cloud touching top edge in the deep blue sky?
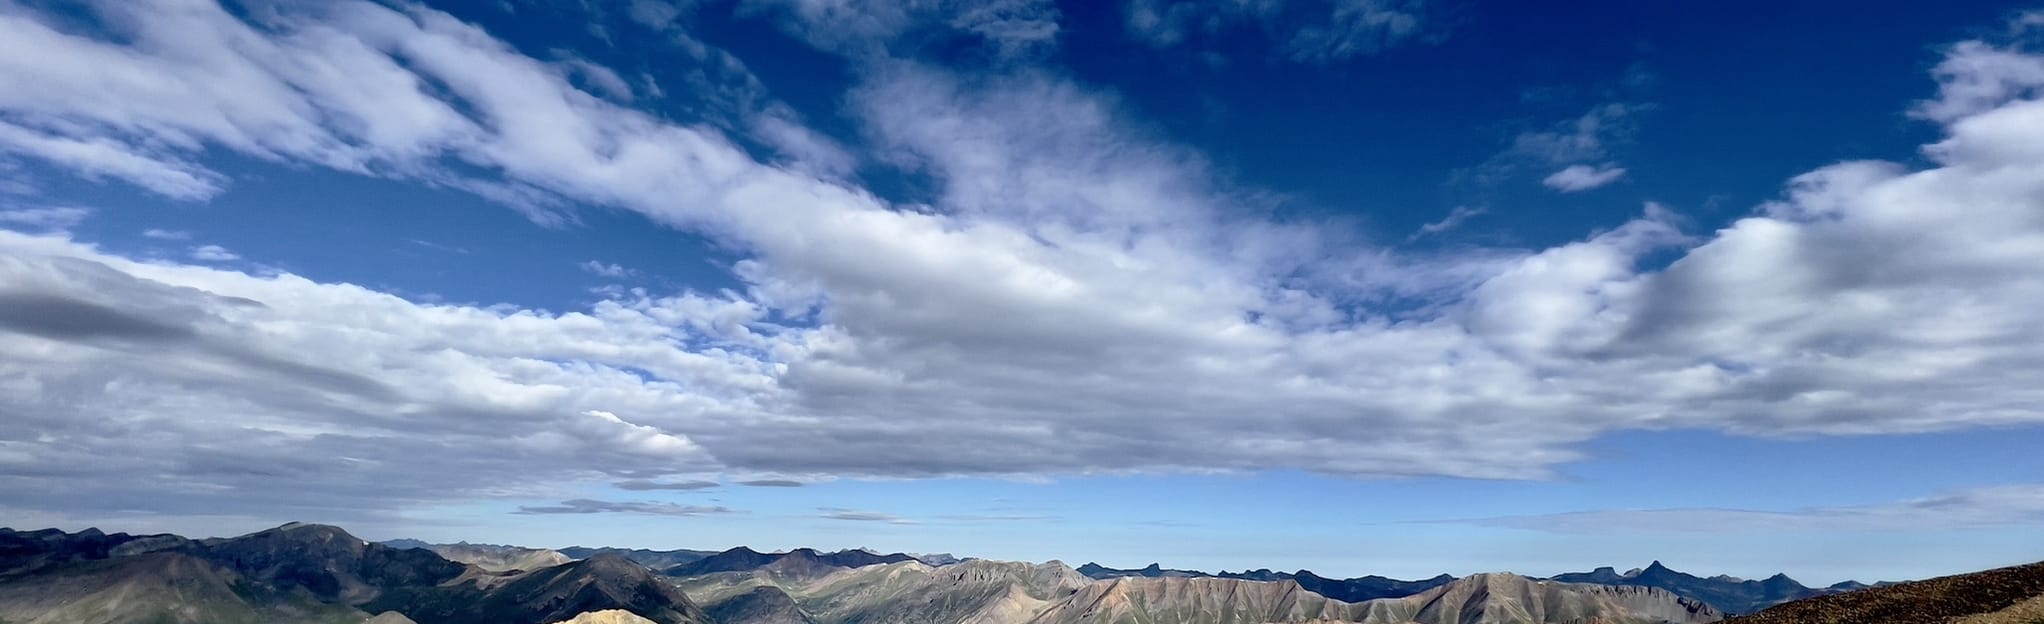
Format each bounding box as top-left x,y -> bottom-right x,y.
1126,0 -> 1427,63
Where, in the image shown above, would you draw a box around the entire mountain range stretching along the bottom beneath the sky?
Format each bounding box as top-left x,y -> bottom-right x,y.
0,524 -> 2044,624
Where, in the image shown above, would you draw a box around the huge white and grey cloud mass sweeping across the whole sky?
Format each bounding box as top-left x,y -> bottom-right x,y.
0,0 -> 2044,514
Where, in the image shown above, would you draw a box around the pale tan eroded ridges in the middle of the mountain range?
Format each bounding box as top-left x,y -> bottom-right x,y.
679,548 -> 1723,624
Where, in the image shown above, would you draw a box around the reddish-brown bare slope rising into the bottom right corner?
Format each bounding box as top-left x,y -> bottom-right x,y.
1725,563 -> 2044,624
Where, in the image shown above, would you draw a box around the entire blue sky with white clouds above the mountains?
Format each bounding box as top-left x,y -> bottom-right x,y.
0,0 -> 2044,583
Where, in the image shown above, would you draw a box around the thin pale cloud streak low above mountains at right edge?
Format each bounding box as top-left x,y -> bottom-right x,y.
1468,483 -> 2044,534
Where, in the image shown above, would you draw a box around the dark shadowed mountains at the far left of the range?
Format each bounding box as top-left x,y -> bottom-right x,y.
0,524 -> 711,624
